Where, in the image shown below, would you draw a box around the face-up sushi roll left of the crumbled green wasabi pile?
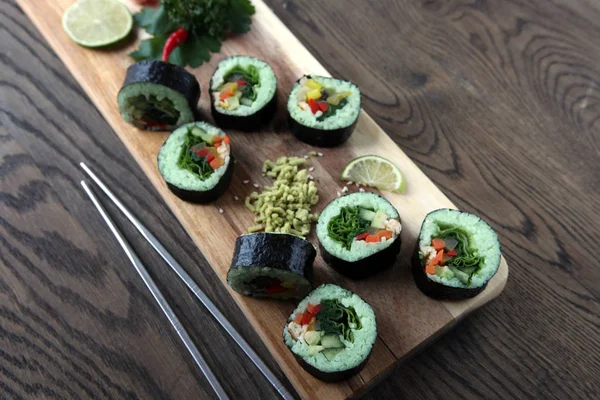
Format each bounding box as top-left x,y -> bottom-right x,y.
158,122 -> 233,203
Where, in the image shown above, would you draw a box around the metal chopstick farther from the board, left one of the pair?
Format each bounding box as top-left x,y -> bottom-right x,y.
81,181 -> 229,400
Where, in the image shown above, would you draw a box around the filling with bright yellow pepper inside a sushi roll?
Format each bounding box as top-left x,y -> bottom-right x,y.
296,76 -> 352,122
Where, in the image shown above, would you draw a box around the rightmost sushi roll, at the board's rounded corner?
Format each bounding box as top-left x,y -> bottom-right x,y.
412,209 -> 501,300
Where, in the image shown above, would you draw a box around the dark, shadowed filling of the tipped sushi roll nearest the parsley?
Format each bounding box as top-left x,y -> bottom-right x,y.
126,94 -> 180,129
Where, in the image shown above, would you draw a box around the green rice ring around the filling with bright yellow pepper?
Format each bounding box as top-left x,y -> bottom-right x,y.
287,75 -> 360,130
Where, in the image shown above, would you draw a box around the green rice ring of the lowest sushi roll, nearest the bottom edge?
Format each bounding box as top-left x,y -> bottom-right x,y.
283,284 -> 377,372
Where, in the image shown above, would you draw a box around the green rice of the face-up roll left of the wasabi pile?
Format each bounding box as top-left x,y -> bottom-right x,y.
158,122 -> 231,191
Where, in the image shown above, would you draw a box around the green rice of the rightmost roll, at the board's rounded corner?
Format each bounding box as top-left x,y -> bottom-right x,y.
419,209 -> 501,288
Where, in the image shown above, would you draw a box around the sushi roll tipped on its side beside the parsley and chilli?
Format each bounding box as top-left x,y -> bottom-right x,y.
117,60 -> 200,131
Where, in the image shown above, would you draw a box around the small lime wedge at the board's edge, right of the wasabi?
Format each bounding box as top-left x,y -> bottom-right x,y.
341,155 -> 404,193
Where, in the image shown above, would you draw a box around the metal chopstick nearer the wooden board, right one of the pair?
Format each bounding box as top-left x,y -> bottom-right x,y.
79,162 -> 294,400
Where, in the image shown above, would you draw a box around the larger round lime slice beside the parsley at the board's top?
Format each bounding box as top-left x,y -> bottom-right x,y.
63,0 -> 133,47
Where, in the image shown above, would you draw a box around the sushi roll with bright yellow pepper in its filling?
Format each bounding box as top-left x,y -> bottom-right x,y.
287,75 -> 360,147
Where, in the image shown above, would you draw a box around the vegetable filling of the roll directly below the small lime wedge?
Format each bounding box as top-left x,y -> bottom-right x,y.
327,206 -> 402,250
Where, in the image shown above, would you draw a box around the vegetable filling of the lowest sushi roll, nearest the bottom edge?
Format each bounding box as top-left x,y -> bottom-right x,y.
287,299 -> 362,360
